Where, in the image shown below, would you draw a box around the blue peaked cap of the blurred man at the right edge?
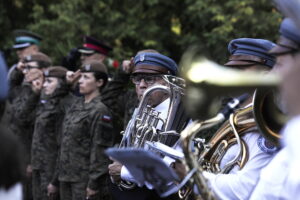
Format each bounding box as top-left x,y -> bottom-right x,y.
269,18 -> 300,55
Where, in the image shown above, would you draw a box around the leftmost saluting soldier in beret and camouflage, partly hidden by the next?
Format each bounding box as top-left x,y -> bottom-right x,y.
8,53 -> 51,199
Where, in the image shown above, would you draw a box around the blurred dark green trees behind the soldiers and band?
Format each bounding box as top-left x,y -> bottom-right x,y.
0,0 -> 281,67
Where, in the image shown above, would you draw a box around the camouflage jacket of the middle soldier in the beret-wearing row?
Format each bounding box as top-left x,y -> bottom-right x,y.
31,93 -> 66,174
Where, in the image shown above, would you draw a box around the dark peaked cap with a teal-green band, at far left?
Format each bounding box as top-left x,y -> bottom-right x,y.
13,30 -> 42,49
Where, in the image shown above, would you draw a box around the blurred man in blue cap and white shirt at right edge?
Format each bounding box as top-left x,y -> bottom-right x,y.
251,18 -> 300,200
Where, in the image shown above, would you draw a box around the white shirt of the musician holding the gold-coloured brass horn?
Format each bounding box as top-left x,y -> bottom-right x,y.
204,133 -> 273,200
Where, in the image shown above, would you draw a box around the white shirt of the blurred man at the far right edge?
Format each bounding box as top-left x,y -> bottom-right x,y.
251,116 -> 300,200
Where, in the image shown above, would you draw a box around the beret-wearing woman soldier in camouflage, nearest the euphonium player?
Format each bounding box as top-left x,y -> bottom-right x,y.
58,61 -> 115,200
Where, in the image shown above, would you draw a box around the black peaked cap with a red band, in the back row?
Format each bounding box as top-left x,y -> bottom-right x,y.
78,36 -> 112,55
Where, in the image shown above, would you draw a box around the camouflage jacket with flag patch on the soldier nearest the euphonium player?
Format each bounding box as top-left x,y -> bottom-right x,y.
59,96 -> 114,190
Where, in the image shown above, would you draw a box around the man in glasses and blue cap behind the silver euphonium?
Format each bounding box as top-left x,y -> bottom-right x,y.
109,51 -> 188,200
